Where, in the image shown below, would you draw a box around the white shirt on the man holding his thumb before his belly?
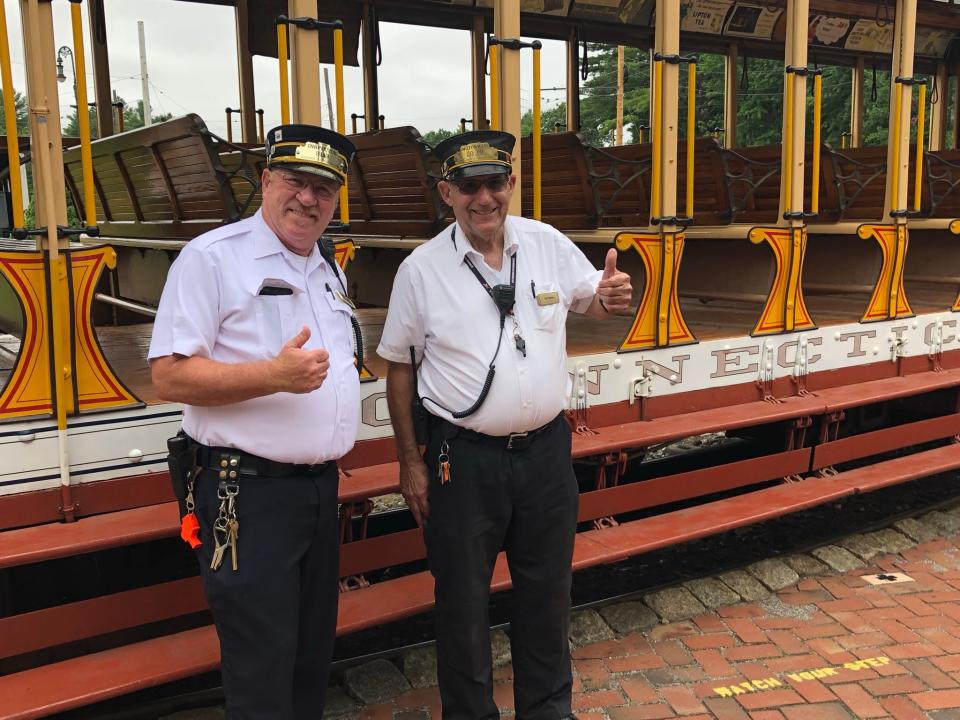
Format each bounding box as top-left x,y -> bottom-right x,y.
149,211 -> 360,464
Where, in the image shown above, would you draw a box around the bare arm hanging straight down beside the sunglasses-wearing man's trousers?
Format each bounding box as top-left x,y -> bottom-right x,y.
387,360 -> 430,525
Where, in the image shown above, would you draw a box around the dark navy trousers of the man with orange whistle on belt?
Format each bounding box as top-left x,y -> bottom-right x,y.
195,463 -> 339,720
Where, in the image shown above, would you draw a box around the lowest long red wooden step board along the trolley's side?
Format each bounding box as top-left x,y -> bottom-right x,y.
0,443 -> 960,720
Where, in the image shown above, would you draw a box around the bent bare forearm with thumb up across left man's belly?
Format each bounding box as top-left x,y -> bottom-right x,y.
150,327 -> 330,407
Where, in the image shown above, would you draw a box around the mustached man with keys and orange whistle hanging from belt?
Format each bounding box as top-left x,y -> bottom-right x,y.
149,125 -> 360,720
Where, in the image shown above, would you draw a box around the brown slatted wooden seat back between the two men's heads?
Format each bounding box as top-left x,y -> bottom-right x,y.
348,126 -> 449,237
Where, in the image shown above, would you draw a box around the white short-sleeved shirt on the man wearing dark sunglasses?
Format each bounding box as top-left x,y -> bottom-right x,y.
377,217 -> 602,435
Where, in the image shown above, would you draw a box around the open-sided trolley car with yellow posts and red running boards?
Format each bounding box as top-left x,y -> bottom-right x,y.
0,0 -> 960,718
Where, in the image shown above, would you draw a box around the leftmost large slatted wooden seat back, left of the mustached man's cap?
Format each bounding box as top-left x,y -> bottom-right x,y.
64,114 -> 260,240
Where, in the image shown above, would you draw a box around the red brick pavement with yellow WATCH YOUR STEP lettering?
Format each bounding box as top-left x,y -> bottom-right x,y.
358,536 -> 960,720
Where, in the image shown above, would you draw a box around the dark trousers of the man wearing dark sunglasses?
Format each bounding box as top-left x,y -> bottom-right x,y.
424,417 -> 579,720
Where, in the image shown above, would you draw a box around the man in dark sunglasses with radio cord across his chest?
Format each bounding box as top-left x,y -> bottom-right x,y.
377,131 -> 632,720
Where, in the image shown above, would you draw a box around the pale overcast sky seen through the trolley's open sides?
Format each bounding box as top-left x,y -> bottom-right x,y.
6,0 -> 566,137
